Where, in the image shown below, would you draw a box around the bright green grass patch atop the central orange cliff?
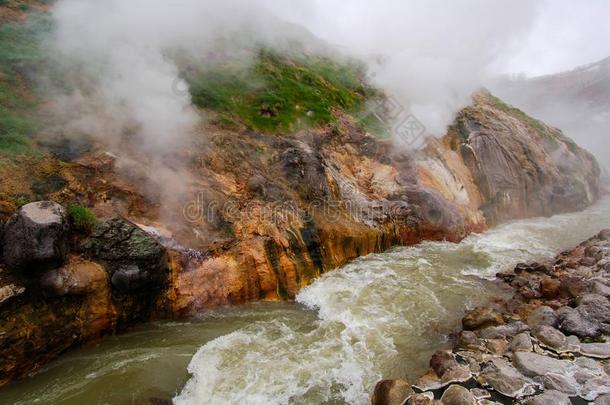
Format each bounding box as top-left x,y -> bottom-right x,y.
184,49 -> 382,133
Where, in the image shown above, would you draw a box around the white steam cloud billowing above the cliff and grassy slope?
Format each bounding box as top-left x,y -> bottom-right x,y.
48,0 -> 610,173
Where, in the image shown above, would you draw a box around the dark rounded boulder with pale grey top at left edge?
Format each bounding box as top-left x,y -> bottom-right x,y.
3,201 -> 68,270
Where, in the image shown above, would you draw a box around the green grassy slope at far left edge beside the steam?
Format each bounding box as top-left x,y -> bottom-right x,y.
0,14 -> 50,156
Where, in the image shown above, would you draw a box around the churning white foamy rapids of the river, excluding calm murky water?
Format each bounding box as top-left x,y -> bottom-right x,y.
174,200 -> 610,405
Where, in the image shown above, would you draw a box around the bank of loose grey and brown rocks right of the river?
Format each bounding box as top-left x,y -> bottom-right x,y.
372,230 -> 610,405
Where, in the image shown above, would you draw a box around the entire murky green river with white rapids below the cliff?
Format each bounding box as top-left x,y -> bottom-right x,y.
0,199 -> 610,405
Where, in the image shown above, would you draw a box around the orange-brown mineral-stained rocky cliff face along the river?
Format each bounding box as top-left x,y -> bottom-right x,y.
0,94 -> 600,384
